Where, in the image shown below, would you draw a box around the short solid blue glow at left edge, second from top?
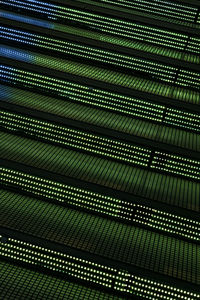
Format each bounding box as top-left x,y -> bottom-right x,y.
0,45 -> 34,63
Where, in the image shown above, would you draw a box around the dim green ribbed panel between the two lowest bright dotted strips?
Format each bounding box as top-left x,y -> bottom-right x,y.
0,191 -> 200,285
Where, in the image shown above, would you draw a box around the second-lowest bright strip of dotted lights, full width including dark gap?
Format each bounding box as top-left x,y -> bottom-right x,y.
0,167 -> 200,241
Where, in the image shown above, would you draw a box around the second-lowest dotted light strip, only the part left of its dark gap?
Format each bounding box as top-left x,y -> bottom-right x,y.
0,168 -> 125,220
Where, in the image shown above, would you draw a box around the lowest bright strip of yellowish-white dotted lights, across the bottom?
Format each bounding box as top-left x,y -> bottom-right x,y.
0,236 -> 200,300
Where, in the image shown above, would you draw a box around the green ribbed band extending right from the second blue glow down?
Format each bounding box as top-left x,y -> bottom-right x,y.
7,52 -> 200,101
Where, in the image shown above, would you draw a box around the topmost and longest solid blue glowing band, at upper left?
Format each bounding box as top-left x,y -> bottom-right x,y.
0,12 -> 54,29
